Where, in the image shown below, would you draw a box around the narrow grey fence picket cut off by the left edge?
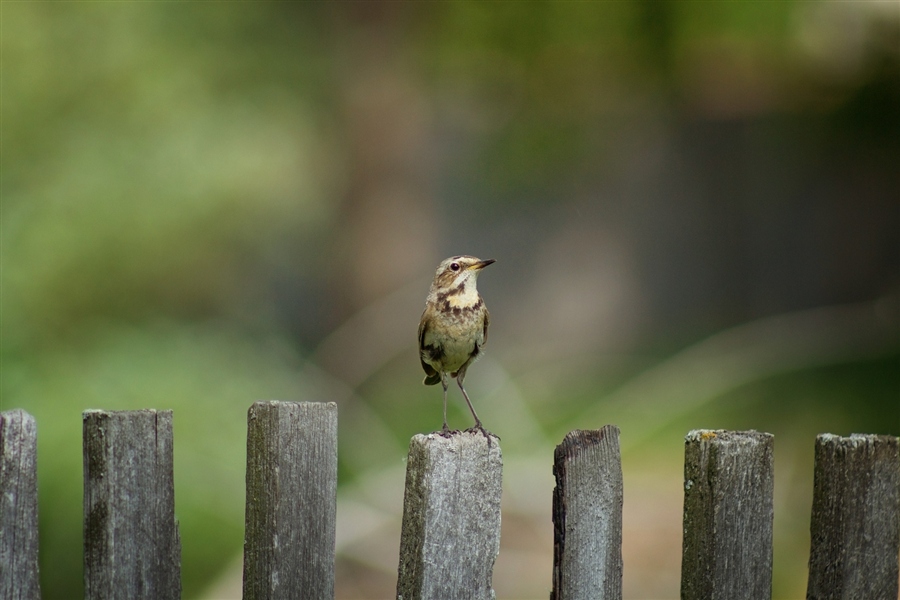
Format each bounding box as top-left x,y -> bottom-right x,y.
0,409 -> 41,600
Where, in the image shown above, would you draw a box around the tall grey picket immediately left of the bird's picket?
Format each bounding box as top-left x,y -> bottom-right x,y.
244,401 -> 337,600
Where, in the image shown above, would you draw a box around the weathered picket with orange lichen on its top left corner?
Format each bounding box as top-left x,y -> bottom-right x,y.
681,430 -> 774,600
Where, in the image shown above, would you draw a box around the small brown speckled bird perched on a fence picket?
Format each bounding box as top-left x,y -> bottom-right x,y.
419,256 -> 494,442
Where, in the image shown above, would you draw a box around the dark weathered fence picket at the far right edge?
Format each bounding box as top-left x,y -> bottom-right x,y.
806,434 -> 900,600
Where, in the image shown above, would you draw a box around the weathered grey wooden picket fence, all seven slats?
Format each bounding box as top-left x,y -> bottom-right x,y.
0,402 -> 900,600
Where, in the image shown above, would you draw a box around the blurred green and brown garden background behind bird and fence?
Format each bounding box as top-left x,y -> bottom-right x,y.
0,0 -> 900,599
